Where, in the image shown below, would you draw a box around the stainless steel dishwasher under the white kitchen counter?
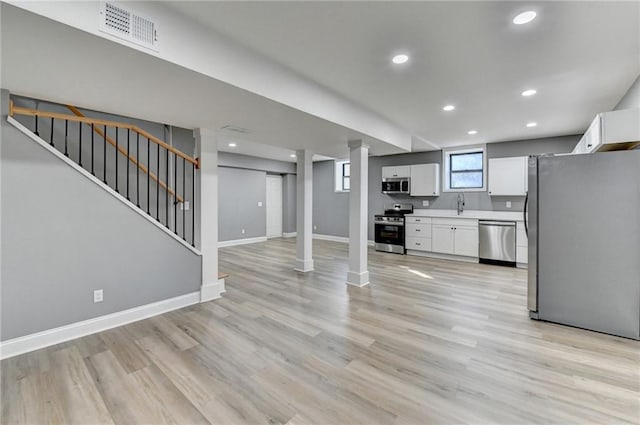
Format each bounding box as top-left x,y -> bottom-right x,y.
478,220 -> 516,267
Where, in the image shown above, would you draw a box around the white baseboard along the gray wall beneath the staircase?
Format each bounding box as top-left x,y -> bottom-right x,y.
0,291 -> 200,359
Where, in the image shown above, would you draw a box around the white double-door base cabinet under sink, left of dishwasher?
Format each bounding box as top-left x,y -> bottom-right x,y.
431,219 -> 478,257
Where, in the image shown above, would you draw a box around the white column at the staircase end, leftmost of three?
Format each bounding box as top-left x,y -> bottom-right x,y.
193,128 -> 224,302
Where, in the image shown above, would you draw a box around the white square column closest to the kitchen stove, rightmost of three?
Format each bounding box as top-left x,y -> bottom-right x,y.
347,140 -> 369,286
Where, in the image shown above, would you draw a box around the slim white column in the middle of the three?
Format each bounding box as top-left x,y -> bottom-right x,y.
295,150 -> 313,272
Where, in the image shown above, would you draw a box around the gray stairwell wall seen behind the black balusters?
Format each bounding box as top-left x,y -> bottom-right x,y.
12,96 -> 199,241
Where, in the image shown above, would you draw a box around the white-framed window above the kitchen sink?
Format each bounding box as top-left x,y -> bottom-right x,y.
442,146 -> 487,192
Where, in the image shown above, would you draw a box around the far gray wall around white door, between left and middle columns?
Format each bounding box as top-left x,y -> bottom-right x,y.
218,152 -> 296,241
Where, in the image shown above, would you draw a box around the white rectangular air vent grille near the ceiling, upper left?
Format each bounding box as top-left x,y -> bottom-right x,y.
100,2 -> 158,51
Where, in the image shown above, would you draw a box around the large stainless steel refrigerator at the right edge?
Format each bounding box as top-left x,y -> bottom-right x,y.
525,150 -> 640,339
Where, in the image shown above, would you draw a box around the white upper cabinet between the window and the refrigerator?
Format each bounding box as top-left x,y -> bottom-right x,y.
489,156 -> 527,196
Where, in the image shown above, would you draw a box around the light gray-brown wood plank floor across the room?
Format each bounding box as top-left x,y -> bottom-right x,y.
1,239 -> 640,425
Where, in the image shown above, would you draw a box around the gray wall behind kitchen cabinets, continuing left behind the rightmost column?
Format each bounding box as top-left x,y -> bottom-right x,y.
313,135 -> 581,240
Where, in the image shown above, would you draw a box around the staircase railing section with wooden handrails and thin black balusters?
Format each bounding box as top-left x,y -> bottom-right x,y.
9,100 -> 200,247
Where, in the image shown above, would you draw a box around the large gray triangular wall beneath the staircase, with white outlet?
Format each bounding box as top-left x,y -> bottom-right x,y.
0,91 -> 202,341
